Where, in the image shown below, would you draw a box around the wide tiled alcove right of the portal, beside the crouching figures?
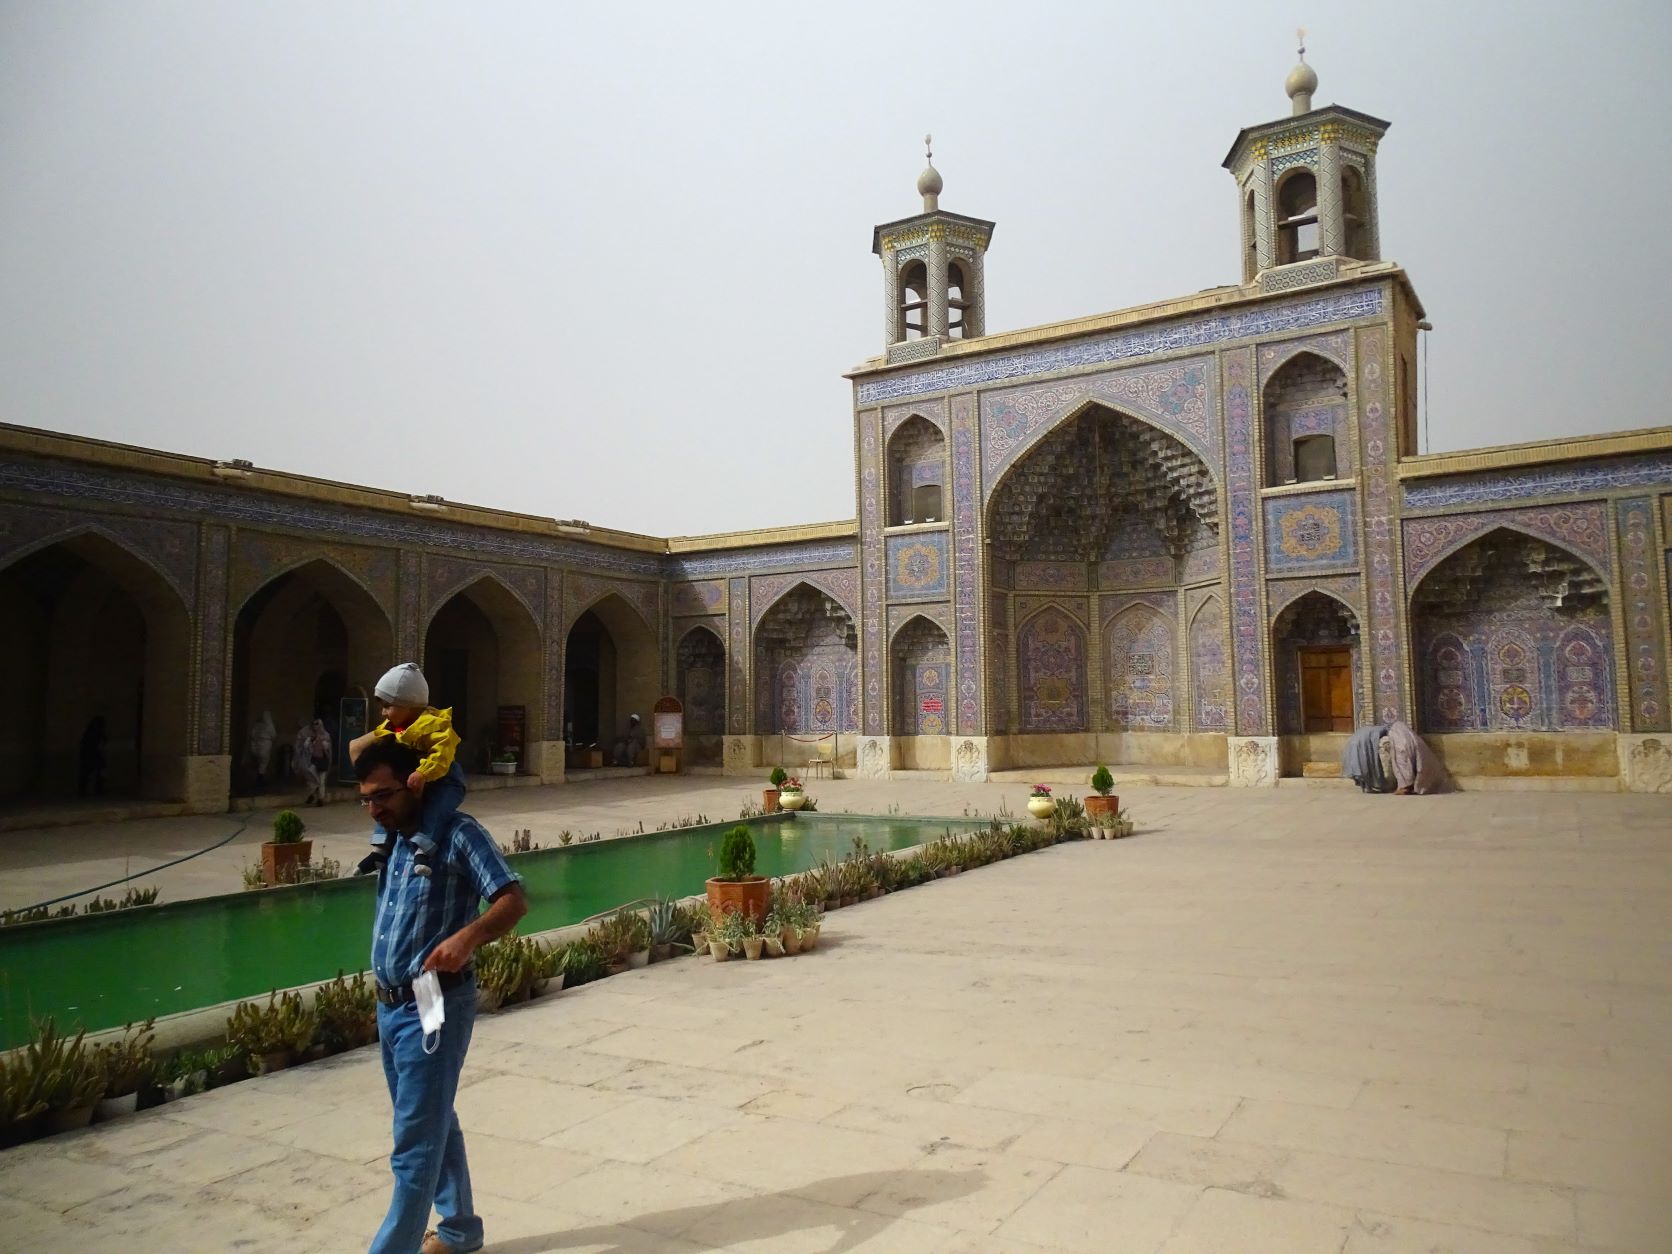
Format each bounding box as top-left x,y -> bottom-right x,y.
1411,528 -> 1618,732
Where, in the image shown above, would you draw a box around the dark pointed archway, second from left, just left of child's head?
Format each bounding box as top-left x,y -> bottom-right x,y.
231,558 -> 400,794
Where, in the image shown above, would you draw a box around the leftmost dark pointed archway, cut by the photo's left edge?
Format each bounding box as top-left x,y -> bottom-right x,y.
0,532 -> 191,801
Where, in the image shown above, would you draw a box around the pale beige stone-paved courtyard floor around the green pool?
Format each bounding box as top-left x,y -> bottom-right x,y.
0,781 -> 1672,1254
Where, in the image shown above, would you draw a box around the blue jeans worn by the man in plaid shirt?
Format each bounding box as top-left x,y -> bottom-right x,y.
371,980 -> 482,1254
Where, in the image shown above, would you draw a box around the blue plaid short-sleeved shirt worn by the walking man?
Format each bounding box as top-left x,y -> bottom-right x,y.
371,813 -> 518,988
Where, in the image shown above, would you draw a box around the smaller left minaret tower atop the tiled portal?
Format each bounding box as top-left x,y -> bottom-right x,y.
871,135 -> 993,361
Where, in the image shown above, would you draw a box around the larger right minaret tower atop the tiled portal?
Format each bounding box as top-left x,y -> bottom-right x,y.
1224,30 -> 1389,291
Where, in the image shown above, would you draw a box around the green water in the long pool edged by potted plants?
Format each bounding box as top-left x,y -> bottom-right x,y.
0,814 -> 978,1048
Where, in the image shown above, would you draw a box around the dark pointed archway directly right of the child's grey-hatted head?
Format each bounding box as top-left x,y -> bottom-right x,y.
423,575 -> 545,774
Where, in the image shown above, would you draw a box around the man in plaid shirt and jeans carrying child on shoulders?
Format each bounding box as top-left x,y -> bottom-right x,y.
354,737 -> 528,1254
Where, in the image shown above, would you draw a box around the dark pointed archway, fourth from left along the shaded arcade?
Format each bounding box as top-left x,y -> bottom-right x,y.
563,592 -> 660,766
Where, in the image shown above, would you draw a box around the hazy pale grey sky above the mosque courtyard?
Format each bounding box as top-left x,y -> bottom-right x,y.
0,0 -> 1672,535
